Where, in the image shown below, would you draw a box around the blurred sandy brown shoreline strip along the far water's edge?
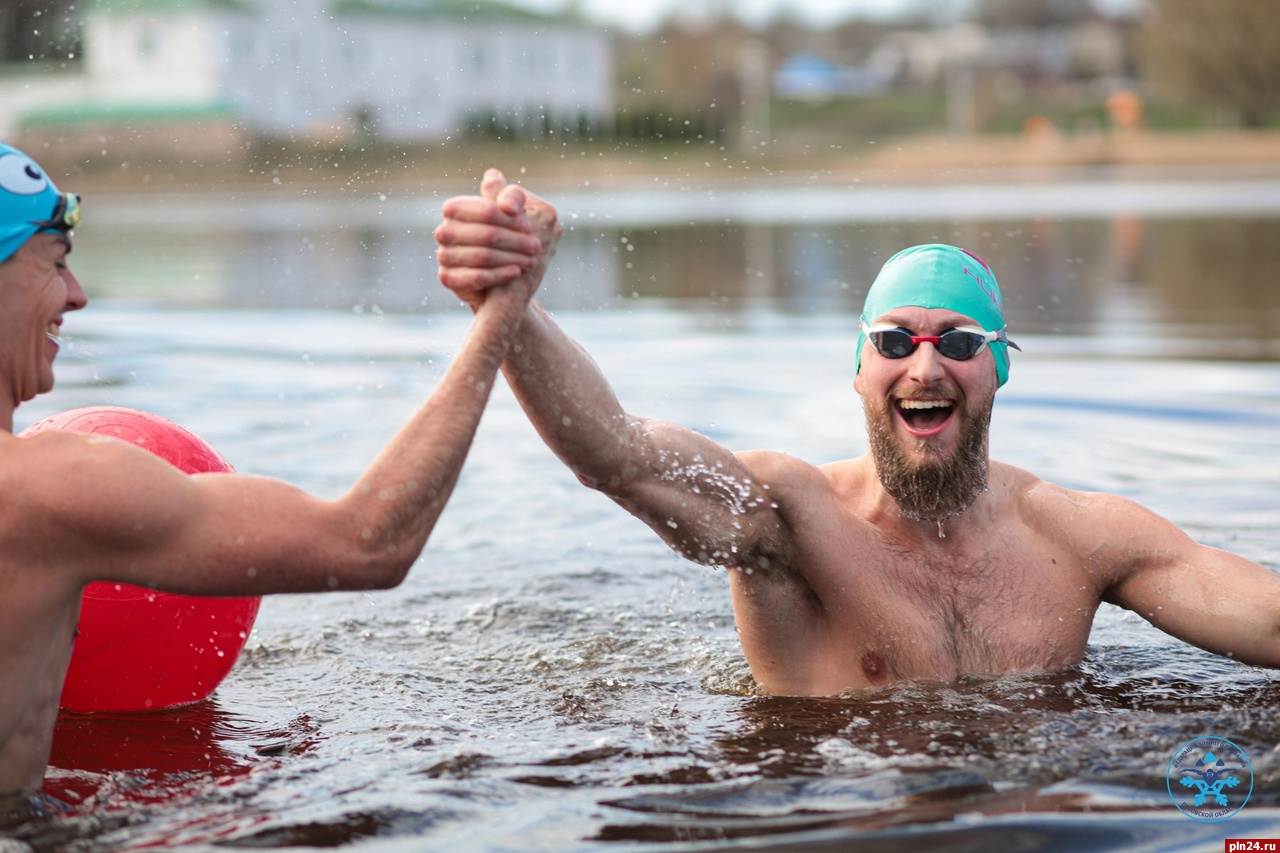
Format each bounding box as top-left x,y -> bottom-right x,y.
52,131 -> 1280,199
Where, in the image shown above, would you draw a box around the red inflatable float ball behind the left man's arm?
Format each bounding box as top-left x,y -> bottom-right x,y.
19,406 -> 261,713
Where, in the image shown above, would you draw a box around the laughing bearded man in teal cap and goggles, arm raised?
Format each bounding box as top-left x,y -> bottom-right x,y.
436,170 -> 1280,695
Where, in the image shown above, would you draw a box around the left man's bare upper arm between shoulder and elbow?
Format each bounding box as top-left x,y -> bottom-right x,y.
28,438 -> 353,596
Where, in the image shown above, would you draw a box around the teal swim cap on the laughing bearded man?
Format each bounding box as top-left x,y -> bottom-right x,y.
855,243 -> 1009,386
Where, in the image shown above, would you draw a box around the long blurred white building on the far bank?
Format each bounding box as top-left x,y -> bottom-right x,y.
0,0 -> 613,142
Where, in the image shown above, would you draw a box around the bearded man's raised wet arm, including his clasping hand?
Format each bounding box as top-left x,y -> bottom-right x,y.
435,170 -> 790,567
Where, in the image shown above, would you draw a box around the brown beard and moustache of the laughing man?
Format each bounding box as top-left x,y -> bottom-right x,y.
863,389 -> 993,521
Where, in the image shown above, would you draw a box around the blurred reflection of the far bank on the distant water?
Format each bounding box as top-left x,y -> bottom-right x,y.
76,185 -> 1280,360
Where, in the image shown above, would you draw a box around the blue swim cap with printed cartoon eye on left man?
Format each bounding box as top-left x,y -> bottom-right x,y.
0,142 -> 79,264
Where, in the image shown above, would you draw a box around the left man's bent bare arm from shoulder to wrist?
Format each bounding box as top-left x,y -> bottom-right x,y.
5,275 -> 529,596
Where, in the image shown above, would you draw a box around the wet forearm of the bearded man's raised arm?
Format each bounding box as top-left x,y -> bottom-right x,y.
503,302 -> 644,491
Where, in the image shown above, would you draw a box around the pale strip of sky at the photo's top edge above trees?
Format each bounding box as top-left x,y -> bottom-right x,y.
508,0 -> 1146,31
